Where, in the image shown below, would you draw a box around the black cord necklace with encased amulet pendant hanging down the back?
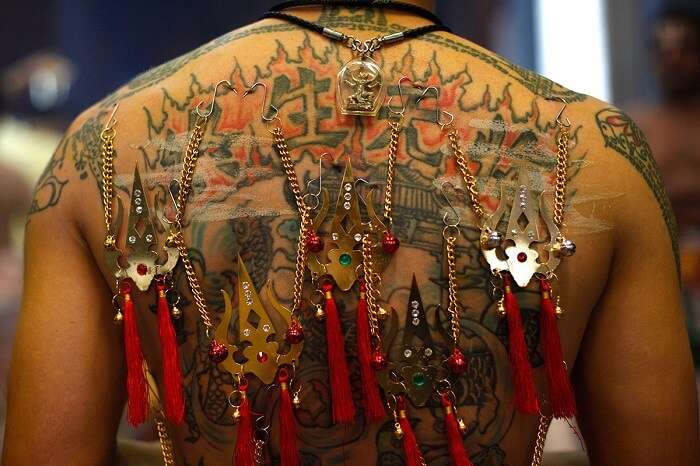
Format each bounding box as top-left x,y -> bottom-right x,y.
263,0 -> 450,116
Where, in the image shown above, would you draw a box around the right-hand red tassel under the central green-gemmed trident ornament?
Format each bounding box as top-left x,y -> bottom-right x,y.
356,279 -> 386,423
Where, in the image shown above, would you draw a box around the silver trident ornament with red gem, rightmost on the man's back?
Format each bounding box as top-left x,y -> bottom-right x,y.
481,169 -> 561,287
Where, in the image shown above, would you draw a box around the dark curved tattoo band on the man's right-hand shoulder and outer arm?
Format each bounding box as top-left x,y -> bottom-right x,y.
596,108 -> 680,267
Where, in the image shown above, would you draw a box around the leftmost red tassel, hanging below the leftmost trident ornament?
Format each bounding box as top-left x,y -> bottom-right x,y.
119,278 -> 148,427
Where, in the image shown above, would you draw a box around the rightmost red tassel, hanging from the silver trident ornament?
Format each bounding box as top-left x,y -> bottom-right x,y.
540,278 -> 576,418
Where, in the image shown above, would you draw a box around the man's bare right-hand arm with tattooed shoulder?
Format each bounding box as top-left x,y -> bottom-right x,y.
575,108 -> 700,466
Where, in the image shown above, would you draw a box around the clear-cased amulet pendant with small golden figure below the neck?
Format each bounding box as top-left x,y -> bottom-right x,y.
336,55 -> 385,116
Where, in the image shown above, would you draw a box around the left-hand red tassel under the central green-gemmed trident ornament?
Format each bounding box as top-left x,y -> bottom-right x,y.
321,280 -> 355,424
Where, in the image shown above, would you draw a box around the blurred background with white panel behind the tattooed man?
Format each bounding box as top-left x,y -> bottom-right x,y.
0,0 -> 700,464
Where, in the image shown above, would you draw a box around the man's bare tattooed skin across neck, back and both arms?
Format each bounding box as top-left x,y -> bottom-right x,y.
3,3 -> 700,466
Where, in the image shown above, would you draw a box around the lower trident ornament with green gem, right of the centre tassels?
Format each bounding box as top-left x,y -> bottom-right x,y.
377,275 -> 444,407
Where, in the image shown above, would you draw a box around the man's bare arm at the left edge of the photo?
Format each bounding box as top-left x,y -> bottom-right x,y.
2,115 -> 125,466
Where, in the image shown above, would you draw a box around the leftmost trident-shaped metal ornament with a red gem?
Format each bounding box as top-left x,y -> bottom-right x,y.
105,166 -> 179,291
